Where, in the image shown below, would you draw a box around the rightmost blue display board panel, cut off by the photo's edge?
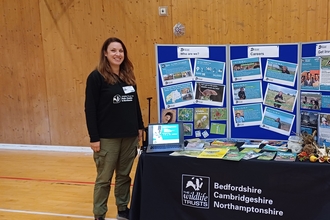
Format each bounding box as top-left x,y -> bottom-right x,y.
299,42 -> 330,146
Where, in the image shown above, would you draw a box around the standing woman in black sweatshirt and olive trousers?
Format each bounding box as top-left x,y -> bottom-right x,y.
85,38 -> 144,220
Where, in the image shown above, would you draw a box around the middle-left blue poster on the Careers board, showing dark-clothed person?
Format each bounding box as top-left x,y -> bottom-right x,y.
231,80 -> 263,104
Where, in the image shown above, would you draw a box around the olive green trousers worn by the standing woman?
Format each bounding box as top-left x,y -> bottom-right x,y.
93,137 -> 138,218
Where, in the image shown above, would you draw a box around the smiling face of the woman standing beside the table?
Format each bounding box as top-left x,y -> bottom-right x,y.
104,42 -> 125,67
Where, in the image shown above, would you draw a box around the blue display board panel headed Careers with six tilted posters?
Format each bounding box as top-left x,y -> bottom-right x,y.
228,44 -> 300,140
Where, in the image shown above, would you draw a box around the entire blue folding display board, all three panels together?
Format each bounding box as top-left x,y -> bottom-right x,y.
156,42 -> 330,142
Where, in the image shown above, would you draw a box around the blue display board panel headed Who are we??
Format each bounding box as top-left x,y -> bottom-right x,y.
156,45 -> 228,139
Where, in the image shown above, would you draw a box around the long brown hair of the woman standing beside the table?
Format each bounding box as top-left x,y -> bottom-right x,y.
97,37 -> 136,85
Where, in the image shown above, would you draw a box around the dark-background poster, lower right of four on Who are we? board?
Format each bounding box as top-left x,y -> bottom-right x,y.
195,82 -> 225,106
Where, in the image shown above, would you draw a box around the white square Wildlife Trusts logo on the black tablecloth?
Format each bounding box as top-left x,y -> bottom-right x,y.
182,174 -> 210,209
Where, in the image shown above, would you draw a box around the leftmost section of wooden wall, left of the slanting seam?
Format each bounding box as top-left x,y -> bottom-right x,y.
0,0 -> 50,144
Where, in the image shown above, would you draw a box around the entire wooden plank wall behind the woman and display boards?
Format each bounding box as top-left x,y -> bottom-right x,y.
0,0 -> 330,146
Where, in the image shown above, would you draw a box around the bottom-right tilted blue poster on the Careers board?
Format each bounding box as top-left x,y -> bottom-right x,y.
260,107 -> 295,136
